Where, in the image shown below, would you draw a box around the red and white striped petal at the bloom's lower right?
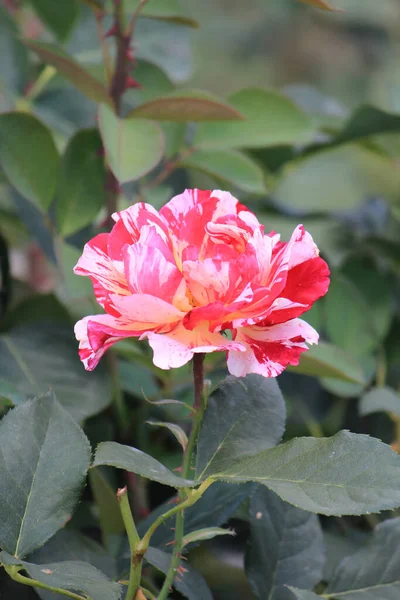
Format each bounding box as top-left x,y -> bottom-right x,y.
228,319 -> 318,377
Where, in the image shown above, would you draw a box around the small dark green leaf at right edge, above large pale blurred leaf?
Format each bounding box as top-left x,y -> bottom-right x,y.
335,105 -> 400,143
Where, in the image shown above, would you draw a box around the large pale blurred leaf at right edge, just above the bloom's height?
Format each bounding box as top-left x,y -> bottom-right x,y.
274,144 -> 400,213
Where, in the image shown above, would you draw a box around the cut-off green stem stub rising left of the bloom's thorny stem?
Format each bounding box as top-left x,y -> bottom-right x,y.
117,487 -> 144,600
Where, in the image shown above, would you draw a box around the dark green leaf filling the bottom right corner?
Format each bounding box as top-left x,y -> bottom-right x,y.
324,518 -> 400,600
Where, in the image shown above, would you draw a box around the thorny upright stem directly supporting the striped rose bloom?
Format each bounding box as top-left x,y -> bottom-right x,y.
158,353 -> 211,600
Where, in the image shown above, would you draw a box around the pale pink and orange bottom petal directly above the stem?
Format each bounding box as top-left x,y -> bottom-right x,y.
141,323 -> 245,369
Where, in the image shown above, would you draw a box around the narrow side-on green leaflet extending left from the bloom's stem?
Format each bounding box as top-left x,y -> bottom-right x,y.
93,442 -> 196,488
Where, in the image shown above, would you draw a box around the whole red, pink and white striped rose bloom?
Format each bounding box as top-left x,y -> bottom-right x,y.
74,190 -> 329,377
